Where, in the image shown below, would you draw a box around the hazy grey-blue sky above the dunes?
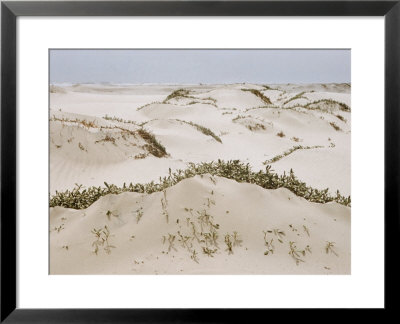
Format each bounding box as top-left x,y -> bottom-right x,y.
50,50 -> 351,84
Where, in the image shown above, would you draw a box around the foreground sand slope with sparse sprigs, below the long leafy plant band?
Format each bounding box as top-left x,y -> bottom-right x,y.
50,174 -> 350,274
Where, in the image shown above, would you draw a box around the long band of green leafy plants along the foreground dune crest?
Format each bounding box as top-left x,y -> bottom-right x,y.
49,160 -> 351,209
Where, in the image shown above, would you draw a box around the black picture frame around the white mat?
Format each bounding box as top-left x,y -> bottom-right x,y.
0,0 -> 400,323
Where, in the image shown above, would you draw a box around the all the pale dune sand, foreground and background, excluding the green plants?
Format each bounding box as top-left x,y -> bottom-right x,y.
50,84 -> 351,274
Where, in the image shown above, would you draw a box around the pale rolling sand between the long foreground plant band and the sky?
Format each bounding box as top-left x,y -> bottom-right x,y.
50,84 -> 351,194
